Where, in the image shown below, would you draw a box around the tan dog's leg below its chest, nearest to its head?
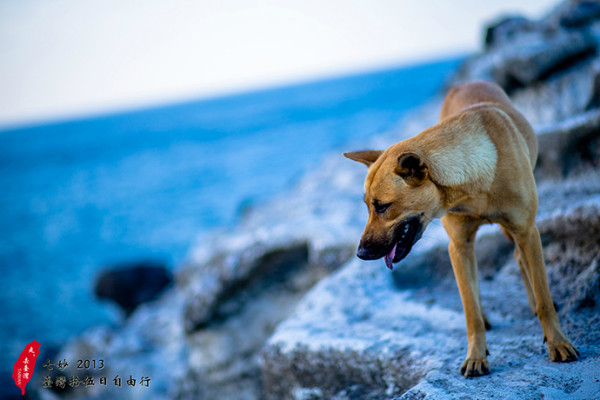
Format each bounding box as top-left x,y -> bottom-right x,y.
442,214 -> 490,377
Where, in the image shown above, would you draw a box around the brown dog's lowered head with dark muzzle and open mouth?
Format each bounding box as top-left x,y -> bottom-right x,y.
344,144 -> 442,269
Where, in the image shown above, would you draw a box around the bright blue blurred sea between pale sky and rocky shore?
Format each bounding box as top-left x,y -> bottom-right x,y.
0,58 -> 461,372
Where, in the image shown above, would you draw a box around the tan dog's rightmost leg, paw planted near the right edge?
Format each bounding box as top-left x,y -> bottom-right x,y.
511,224 -> 579,362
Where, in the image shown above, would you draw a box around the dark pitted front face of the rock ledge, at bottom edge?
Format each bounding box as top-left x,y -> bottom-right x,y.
262,345 -> 424,400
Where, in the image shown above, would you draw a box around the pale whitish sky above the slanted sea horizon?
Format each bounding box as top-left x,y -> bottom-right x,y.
0,0 -> 556,126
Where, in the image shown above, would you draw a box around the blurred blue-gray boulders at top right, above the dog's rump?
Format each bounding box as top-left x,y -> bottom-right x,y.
446,1 -> 600,126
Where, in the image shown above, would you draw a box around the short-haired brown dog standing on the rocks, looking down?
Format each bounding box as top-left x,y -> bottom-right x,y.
344,82 -> 579,376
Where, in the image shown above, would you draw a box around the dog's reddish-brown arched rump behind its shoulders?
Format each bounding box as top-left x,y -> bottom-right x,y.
440,81 -> 537,169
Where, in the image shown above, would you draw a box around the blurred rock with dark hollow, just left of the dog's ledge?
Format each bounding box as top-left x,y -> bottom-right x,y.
178,245 -> 338,398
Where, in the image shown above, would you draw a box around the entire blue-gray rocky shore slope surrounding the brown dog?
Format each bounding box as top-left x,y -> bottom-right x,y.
32,1 -> 600,400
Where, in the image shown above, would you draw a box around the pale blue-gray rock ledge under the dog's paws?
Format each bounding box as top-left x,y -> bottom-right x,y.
262,194 -> 600,399
